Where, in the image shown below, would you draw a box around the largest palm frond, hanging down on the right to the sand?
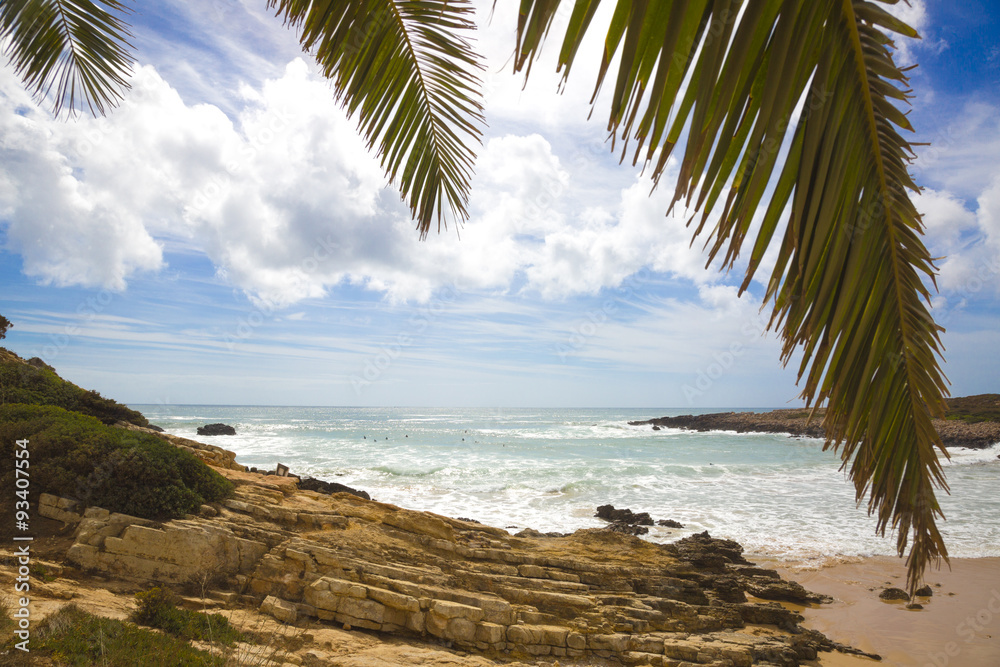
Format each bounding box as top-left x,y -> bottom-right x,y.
515,0 -> 947,593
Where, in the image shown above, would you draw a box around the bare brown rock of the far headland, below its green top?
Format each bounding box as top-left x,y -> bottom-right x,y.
629,409 -> 1000,449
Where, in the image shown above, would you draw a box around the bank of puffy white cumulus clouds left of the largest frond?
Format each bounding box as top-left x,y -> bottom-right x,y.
0,60 -> 736,307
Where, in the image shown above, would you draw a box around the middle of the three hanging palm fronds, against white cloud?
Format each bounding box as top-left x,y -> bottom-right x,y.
268,0 -> 484,237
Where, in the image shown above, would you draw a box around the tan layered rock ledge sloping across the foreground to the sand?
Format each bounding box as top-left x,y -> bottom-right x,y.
21,469 -> 884,667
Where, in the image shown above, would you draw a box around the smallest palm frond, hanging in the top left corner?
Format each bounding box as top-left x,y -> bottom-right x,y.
0,0 -> 132,116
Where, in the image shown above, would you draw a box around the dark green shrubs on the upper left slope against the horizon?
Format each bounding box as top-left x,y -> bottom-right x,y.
0,348 -> 149,426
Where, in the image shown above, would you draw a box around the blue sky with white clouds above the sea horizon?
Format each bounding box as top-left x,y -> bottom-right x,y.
0,0 -> 1000,408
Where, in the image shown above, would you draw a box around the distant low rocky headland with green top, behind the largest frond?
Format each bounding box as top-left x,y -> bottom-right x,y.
629,394 -> 1000,449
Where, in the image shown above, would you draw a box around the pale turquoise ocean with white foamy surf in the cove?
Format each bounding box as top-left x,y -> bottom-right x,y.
131,405 -> 1000,567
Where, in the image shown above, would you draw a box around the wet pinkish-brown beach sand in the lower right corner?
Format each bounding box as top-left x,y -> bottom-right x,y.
758,557 -> 1000,667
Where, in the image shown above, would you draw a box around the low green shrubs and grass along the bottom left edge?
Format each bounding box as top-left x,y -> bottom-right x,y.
0,604 -> 225,667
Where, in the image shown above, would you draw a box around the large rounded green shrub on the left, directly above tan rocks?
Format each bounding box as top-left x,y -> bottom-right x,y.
0,404 -> 233,519
